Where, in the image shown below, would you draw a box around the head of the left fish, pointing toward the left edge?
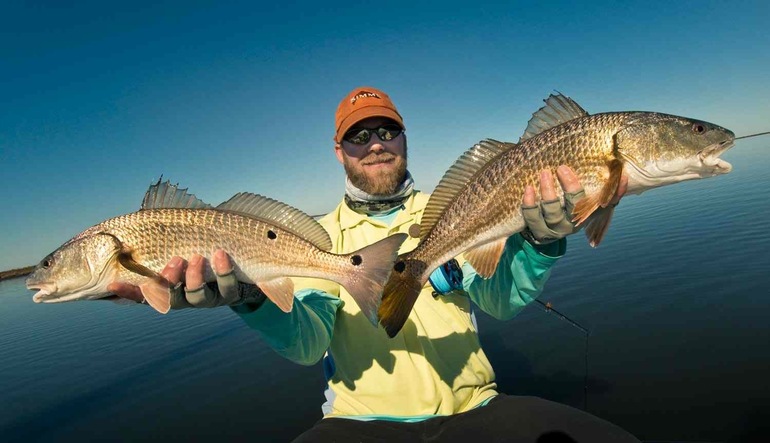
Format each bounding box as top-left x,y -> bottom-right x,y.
26,233 -> 121,303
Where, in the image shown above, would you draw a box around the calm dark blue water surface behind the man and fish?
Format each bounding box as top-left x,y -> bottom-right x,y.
0,137 -> 770,442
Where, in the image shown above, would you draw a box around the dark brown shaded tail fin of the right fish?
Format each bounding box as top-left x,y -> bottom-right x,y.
379,258 -> 424,338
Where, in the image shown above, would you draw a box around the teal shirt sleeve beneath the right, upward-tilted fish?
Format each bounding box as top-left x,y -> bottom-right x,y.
463,234 -> 567,320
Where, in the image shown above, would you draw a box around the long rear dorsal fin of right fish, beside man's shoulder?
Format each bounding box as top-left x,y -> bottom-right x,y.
420,139 -> 516,238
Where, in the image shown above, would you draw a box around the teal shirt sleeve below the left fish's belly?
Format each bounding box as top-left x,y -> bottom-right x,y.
232,289 -> 343,366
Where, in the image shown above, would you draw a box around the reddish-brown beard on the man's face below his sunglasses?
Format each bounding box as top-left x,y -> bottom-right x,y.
342,147 -> 406,196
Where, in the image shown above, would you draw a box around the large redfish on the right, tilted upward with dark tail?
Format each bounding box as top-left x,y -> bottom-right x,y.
379,94 -> 735,337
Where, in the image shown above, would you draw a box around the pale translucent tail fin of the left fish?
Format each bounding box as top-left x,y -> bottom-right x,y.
339,234 -> 408,327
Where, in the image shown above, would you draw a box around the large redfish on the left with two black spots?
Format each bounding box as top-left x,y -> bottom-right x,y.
27,181 -> 406,326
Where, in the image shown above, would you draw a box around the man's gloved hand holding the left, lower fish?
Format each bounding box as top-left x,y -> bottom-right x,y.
107,249 -> 264,309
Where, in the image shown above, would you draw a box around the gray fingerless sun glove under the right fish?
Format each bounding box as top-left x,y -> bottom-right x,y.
521,189 -> 585,245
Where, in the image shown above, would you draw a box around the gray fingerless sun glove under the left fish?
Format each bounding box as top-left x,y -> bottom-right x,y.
169,271 -> 265,309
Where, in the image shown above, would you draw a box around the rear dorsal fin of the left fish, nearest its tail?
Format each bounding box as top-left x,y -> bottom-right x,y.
217,192 -> 332,251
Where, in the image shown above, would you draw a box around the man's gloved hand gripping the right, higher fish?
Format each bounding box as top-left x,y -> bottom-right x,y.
521,165 -> 628,245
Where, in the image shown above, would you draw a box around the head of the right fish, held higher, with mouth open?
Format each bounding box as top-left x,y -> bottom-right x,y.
615,112 -> 735,194
